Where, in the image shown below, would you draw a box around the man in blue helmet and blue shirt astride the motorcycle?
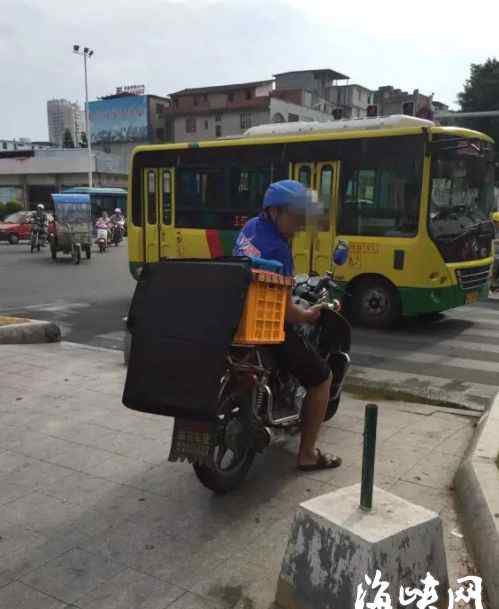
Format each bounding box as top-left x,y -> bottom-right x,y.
234,180 -> 341,471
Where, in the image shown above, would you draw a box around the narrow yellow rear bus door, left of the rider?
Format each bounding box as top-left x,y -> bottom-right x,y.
143,167 -> 175,263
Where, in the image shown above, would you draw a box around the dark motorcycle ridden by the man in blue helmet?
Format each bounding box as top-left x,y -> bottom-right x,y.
170,243 -> 350,493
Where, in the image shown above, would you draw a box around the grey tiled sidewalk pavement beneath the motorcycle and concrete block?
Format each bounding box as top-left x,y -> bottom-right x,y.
0,342 -> 476,609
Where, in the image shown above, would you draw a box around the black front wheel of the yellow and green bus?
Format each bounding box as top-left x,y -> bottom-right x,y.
352,278 -> 401,328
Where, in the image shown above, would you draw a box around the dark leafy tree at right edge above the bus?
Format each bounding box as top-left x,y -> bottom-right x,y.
458,58 -> 499,144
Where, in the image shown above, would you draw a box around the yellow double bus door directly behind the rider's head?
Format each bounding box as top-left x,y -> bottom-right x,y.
292,161 -> 339,275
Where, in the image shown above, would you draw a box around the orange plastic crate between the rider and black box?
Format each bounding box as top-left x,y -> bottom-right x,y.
233,269 -> 293,345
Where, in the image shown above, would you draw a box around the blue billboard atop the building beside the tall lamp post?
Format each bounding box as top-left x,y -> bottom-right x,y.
88,95 -> 148,144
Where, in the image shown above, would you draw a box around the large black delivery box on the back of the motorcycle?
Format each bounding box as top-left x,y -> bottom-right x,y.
123,258 -> 251,419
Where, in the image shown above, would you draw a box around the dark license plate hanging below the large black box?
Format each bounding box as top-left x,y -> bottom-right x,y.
168,419 -> 216,463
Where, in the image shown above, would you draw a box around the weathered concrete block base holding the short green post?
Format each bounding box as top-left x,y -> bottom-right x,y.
276,485 -> 449,609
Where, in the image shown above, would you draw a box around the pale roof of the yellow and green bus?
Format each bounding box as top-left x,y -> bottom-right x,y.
134,115 -> 494,154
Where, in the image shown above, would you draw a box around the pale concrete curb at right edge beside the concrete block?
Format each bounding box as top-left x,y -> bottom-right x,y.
454,394 -> 499,609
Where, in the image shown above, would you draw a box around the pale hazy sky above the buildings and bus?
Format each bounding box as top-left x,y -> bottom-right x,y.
0,0 -> 499,140
